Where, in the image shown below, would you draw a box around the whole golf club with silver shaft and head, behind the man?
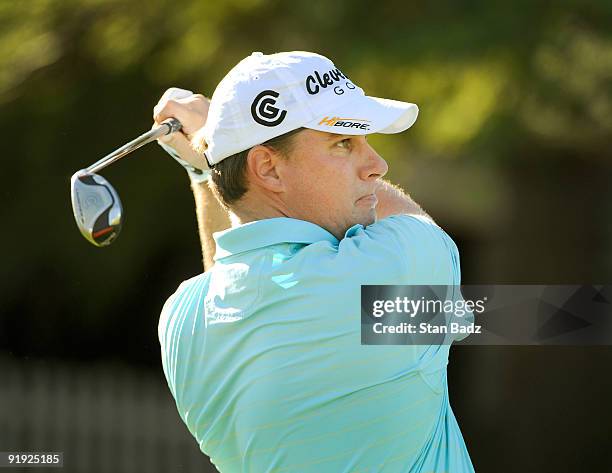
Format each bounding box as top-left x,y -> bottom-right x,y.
70,118 -> 182,247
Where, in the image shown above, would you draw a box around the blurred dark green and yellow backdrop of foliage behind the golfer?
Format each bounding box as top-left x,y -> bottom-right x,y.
0,0 -> 612,472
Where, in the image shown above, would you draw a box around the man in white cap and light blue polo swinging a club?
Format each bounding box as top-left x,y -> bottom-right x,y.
154,52 -> 473,473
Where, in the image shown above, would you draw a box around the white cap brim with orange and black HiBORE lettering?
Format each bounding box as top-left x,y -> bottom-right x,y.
304,95 -> 419,135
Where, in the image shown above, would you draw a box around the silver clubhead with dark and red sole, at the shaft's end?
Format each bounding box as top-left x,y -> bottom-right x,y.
70,169 -> 123,246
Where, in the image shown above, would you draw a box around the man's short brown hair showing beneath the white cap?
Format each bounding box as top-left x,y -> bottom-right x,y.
196,128 -> 305,210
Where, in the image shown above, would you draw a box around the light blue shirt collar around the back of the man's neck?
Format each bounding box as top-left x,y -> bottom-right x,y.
213,217 -> 342,261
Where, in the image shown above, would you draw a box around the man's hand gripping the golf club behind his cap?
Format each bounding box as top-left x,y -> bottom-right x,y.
153,87 -> 210,170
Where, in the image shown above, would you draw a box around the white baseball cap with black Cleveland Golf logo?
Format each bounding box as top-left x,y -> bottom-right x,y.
201,51 -> 419,165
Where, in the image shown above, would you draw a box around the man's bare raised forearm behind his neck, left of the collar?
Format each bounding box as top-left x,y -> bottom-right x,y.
191,178 -> 231,271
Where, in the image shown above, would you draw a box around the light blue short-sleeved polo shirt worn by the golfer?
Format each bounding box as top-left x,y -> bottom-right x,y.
159,215 -> 474,473
